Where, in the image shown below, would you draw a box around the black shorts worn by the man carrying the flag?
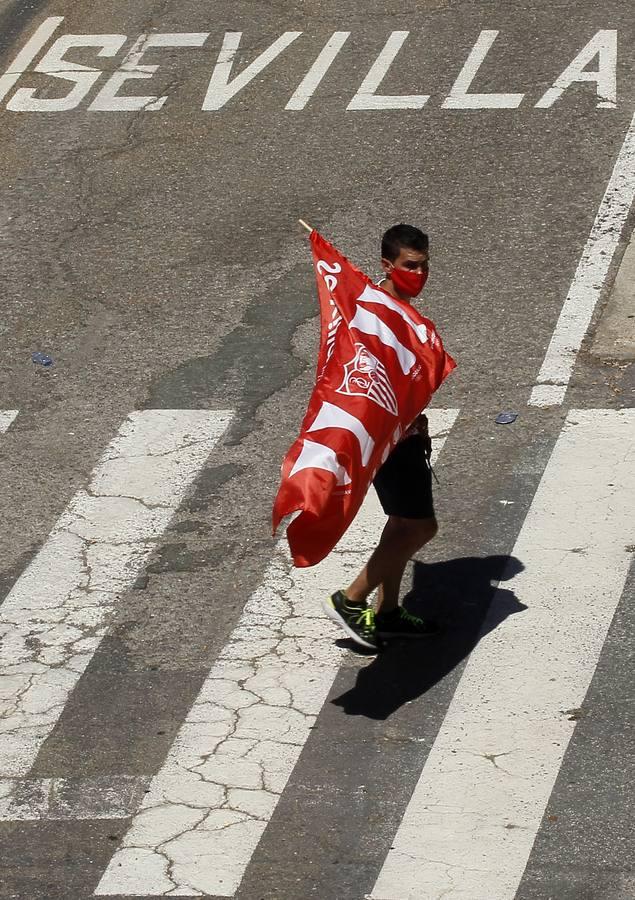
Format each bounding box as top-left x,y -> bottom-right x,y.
373,434 -> 434,519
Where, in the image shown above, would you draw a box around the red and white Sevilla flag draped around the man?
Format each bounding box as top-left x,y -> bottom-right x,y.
273,231 -> 456,566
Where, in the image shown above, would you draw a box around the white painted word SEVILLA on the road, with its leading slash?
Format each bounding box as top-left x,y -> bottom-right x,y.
0,17 -> 628,112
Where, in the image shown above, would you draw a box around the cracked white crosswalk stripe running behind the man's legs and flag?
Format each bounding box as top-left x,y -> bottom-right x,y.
95,409 -> 458,897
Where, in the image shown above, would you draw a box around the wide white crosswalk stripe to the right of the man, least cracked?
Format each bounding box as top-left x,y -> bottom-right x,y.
372,409 -> 635,900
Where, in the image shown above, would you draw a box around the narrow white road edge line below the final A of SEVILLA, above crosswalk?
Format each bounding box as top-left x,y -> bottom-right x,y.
529,116 -> 635,407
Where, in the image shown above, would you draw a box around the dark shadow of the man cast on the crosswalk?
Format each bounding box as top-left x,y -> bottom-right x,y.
331,556 -> 527,719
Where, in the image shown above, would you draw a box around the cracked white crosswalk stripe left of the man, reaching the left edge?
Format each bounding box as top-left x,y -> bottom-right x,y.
0,409 -> 232,800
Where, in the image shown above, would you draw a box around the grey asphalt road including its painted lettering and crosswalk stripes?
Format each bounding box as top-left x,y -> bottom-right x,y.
0,0 -> 635,900
